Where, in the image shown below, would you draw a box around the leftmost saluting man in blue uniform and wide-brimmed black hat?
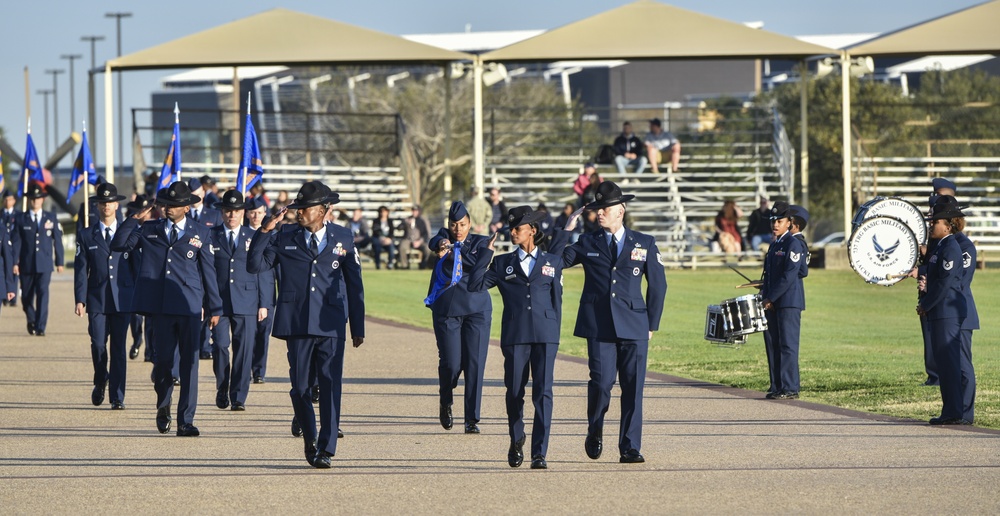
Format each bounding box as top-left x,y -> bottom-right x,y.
111,181 -> 222,437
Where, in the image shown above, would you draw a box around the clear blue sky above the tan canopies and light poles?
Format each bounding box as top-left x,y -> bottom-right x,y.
0,0 -> 980,165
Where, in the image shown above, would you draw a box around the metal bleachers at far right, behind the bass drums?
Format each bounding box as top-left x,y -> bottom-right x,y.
855,156 -> 1000,259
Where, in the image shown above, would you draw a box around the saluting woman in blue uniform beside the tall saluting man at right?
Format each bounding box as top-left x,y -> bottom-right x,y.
469,206 -> 568,469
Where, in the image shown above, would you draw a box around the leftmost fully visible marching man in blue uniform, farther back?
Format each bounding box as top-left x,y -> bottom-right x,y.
12,183 -> 64,337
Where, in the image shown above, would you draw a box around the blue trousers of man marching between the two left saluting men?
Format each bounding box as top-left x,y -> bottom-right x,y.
212,315 -> 257,403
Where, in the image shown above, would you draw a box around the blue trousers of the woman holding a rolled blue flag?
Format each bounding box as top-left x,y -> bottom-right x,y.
434,312 -> 493,424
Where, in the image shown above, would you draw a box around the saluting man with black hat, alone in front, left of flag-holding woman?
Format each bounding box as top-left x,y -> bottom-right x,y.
247,181 -> 365,468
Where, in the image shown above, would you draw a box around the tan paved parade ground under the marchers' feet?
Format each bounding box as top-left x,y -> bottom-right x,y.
0,280 -> 1000,514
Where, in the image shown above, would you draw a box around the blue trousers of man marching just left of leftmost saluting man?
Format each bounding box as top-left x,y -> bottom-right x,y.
87,313 -> 132,402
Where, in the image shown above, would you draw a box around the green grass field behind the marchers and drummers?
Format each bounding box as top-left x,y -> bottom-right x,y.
365,268 -> 1000,428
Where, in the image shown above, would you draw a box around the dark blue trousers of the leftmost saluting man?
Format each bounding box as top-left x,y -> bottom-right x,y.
148,315 -> 201,426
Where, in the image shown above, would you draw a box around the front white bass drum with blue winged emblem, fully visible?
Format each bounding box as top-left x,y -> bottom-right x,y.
847,217 -> 920,287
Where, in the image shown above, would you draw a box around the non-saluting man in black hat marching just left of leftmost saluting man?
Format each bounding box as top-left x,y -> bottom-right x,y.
73,183 -> 135,410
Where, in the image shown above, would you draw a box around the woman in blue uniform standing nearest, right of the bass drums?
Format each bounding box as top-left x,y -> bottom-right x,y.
917,202 -> 972,425
